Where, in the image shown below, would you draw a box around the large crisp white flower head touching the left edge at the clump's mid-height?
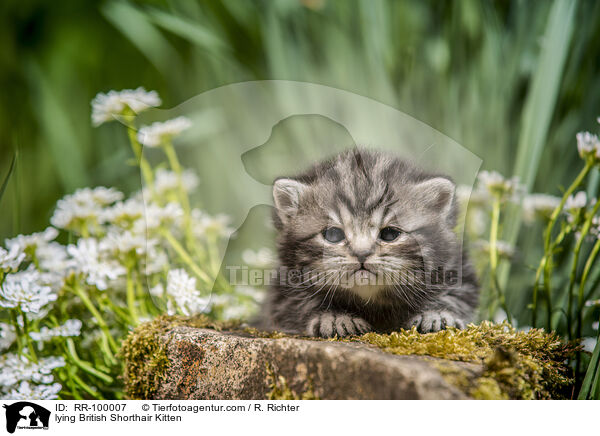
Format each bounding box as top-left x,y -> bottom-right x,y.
0,270 -> 56,313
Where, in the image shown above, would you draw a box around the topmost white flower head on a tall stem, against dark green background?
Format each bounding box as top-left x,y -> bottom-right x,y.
92,87 -> 162,126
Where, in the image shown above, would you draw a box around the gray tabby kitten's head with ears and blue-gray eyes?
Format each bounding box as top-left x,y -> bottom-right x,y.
274,153 -> 454,302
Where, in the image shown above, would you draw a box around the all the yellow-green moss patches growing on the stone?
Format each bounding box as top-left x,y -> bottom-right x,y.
121,315 -> 578,399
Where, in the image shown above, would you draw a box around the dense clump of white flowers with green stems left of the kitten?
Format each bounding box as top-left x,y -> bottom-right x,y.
0,88 -> 258,400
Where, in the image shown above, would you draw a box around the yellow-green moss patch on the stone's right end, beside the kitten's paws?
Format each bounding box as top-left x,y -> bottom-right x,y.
352,322 -> 578,399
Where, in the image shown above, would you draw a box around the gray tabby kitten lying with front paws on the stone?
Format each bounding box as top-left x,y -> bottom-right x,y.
262,149 -> 478,337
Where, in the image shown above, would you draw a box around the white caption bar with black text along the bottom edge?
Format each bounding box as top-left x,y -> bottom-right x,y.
0,400 -> 598,436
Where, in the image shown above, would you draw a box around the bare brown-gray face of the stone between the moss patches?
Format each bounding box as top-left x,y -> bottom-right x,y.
153,326 -> 480,399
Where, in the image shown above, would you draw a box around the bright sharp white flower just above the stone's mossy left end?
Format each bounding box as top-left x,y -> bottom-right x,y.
167,269 -> 209,316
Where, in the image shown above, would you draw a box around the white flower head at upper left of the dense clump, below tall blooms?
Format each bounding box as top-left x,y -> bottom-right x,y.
50,186 -> 123,230
